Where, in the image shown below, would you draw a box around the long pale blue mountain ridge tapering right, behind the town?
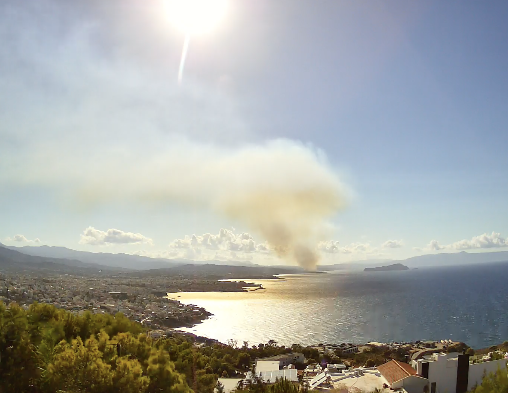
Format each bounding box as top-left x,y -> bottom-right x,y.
8,246 -> 255,270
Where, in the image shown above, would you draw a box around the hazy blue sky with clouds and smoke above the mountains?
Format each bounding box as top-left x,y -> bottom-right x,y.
0,0 -> 508,264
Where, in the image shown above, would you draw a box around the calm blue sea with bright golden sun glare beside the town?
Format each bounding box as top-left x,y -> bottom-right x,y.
170,262 -> 508,349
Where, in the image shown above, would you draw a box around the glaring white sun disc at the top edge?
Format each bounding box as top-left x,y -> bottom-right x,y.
165,0 -> 228,35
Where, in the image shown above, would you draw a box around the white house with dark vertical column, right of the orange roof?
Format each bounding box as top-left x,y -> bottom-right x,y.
411,352 -> 508,393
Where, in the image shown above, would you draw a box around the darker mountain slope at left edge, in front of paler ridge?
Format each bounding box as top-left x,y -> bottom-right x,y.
0,246 -> 117,273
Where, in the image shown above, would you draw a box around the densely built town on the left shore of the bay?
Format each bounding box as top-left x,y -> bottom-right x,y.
0,273 -> 210,329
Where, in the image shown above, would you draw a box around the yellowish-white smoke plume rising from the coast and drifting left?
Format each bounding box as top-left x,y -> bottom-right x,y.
9,140 -> 345,270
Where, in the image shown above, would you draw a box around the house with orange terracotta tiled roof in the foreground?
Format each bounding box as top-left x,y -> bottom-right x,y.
377,360 -> 429,393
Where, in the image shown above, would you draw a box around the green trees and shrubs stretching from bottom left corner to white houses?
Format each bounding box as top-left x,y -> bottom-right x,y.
0,302 -> 318,393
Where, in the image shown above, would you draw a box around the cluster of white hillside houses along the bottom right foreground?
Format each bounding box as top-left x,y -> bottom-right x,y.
218,340 -> 508,393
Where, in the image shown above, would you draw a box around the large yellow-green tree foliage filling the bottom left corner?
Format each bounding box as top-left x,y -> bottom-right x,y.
0,302 -> 190,393
